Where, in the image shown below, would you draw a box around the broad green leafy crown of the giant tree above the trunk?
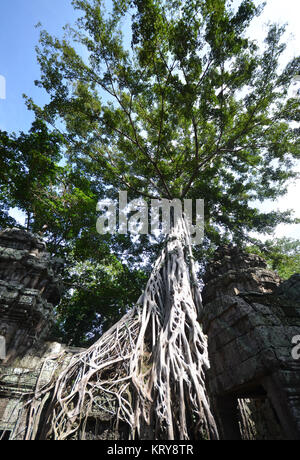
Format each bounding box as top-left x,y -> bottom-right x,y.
24,0 -> 300,246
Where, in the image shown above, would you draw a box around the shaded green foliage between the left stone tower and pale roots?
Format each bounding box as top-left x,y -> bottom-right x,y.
54,257 -> 147,347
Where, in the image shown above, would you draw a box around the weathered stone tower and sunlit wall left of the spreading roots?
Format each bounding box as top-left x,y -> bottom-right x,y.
0,229 -> 84,439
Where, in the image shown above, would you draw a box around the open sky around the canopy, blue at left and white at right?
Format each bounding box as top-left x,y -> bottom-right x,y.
0,0 -> 300,238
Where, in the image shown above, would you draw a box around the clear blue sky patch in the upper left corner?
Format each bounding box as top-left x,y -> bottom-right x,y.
0,0 -> 76,132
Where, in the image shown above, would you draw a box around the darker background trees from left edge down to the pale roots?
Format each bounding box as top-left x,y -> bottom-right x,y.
0,120 -> 146,345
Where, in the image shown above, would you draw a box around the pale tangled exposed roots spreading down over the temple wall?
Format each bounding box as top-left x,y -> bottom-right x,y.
20,220 -> 218,440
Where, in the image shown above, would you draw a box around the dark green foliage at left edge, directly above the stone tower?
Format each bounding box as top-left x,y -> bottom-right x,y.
0,120 -> 62,228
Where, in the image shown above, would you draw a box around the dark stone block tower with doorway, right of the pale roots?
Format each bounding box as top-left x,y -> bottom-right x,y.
202,246 -> 300,439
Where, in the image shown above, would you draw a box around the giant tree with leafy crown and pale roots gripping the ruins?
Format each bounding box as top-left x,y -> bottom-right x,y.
18,0 -> 300,439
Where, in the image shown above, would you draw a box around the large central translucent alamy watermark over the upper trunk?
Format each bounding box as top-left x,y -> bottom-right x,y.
96,192 -> 204,244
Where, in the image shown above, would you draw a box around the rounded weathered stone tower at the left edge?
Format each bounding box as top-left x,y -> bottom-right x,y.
0,228 -> 61,364
